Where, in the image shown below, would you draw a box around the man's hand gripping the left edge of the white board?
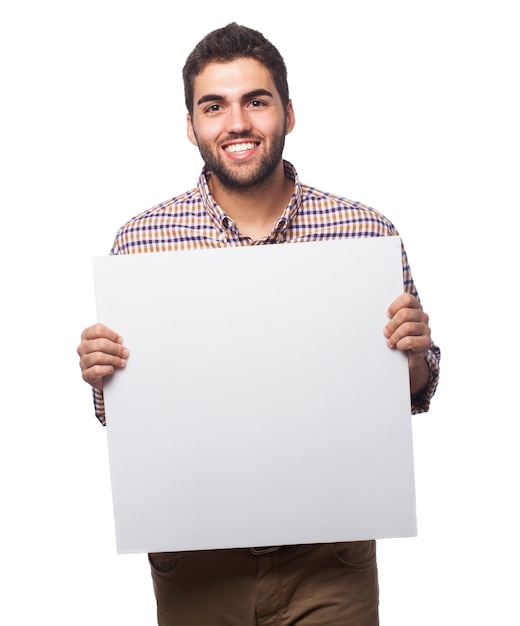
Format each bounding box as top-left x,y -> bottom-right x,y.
78,324 -> 128,391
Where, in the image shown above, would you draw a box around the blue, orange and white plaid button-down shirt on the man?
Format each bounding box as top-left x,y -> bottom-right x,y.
94,161 -> 440,424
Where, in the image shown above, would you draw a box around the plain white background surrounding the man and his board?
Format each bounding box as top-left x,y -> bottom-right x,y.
0,0 -> 520,626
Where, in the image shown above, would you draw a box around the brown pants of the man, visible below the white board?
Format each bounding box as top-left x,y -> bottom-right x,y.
149,541 -> 379,626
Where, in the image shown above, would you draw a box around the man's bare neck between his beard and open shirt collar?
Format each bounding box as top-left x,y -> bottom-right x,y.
208,161 -> 294,240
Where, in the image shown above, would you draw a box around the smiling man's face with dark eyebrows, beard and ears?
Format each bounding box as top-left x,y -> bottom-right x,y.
188,58 -> 294,190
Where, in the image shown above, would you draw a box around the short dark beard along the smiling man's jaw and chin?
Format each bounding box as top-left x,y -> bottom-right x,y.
193,124 -> 285,191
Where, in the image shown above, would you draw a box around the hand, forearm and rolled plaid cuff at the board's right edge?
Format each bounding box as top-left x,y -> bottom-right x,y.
383,293 -> 440,412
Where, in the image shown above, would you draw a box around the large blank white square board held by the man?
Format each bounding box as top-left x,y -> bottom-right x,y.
94,237 -> 416,553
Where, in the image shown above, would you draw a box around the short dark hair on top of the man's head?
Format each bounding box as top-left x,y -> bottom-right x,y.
182,22 -> 289,114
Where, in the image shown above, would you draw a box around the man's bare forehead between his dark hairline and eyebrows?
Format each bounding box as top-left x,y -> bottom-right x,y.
193,58 -> 278,102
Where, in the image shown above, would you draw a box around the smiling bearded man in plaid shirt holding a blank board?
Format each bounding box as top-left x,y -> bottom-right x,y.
78,23 -> 440,626
